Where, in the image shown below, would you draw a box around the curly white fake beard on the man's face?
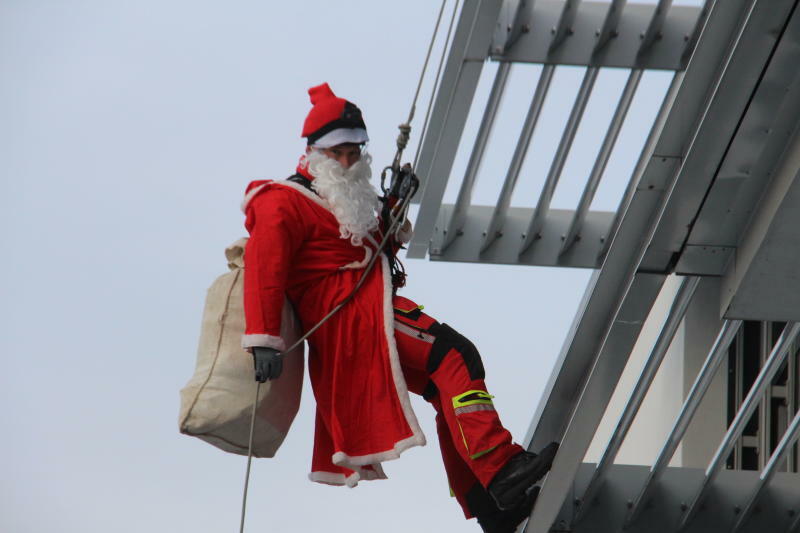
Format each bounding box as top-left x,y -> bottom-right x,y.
305,150 -> 380,246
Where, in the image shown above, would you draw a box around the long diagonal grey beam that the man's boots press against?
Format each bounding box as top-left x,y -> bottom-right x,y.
518,0 -> 768,533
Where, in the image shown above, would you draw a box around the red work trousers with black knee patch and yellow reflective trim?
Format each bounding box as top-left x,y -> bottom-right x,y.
395,297 -> 522,517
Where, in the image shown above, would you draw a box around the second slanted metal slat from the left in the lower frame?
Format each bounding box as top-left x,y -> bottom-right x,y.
625,320 -> 742,527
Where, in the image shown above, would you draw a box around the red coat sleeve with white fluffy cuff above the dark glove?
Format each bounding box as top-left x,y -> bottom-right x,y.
242,186 -> 305,350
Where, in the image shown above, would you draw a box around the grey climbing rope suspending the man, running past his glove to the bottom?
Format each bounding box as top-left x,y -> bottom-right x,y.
239,0 -> 459,533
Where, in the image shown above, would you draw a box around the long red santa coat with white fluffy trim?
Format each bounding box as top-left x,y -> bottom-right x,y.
242,175 -> 425,486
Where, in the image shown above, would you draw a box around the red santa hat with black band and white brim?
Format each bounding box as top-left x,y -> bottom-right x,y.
302,83 -> 369,148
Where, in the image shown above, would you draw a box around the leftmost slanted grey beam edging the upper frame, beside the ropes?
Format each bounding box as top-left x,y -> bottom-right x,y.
408,0 -> 500,258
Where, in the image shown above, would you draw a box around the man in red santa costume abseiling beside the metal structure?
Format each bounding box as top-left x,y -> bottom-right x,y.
242,84 -> 557,533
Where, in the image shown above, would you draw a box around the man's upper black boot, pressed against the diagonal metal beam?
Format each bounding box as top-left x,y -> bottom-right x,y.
489,442 -> 558,510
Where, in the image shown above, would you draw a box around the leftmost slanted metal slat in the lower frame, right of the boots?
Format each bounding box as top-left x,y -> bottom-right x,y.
575,276 -> 700,522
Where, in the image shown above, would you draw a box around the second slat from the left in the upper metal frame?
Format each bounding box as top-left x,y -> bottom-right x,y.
481,65 -> 555,252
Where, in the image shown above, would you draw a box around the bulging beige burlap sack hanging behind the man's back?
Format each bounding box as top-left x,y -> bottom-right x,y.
179,238 -> 304,457
